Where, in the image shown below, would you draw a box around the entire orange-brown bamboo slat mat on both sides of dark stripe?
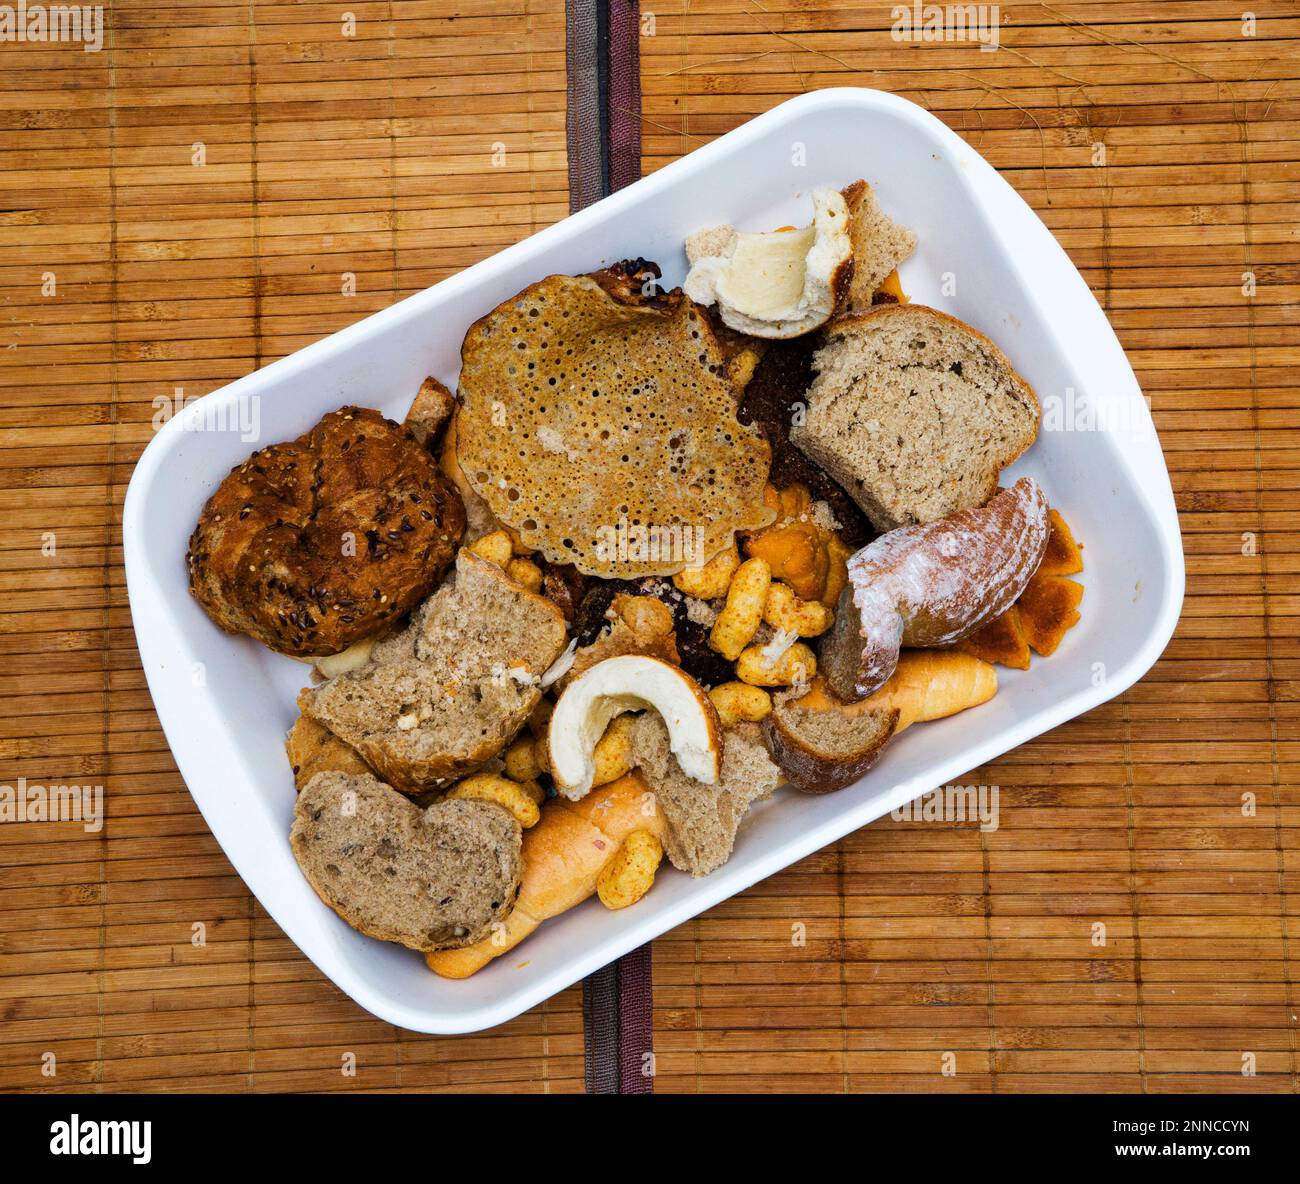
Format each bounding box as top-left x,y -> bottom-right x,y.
0,0 -> 1300,1092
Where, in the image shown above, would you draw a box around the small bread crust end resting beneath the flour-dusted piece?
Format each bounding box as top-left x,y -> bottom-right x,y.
762,699 -> 898,793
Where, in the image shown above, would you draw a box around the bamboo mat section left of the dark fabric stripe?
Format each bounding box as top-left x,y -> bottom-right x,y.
0,0 -> 582,1090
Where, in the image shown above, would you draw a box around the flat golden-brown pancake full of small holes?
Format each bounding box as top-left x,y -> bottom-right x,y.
456,276 -> 772,578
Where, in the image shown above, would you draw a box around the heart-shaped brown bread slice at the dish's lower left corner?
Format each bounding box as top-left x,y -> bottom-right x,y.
289,772 -> 523,953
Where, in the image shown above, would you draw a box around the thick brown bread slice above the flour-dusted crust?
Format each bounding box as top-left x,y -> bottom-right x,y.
790,304 -> 1039,530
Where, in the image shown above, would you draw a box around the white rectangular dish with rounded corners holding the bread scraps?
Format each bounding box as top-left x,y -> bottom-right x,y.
124,90 -> 1183,1033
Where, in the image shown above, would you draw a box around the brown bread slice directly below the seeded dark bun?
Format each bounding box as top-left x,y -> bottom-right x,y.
306,550 -> 568,793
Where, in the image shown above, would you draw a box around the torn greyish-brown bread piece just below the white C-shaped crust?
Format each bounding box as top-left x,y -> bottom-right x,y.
632,711 -> 781,876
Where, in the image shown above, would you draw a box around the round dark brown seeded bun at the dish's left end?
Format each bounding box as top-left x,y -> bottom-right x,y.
186,407 -> 465,658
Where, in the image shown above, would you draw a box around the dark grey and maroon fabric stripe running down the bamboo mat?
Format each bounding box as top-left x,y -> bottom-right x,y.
564,0 -> 654,1093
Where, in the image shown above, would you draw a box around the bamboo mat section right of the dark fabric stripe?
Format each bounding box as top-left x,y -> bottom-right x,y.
641,0 -> 1300,1092
